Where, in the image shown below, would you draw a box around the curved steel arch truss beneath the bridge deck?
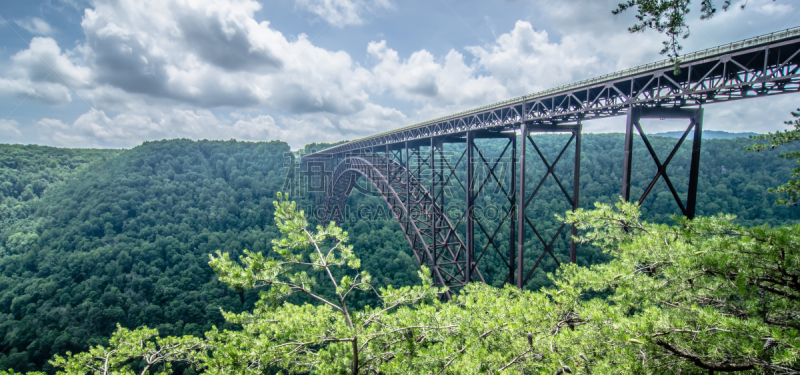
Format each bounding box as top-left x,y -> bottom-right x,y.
325,154 -> 482,288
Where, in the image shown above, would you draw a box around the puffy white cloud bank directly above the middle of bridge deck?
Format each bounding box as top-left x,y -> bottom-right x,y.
367,18 -> 657,120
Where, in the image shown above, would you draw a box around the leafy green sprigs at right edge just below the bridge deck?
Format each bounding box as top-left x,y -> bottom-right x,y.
748,108 -> 800,205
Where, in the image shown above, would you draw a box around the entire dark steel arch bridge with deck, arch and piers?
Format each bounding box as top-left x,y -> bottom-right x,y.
302,28 -> 800,288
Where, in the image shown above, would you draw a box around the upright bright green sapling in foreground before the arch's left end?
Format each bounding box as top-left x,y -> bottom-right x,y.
207,194 -> 443,374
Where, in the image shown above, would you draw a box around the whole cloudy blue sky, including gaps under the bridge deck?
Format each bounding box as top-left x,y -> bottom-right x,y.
0,0 -> 800,149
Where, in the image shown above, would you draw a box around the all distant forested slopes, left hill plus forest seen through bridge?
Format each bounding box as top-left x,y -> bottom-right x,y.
0,134 -> 800,370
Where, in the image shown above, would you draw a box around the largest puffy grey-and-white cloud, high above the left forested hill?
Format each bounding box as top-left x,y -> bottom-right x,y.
71,0 -> 369,113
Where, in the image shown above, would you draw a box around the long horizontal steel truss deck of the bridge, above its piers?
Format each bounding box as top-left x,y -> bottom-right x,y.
304,28 -> 800,158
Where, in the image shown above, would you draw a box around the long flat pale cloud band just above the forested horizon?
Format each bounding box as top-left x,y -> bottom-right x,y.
30,104 -> 406,148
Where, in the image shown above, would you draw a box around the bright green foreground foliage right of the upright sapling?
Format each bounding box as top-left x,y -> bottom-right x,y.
360,203 -> 800,374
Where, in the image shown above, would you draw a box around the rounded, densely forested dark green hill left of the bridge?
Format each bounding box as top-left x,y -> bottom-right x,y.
0,140 -> 289,373
